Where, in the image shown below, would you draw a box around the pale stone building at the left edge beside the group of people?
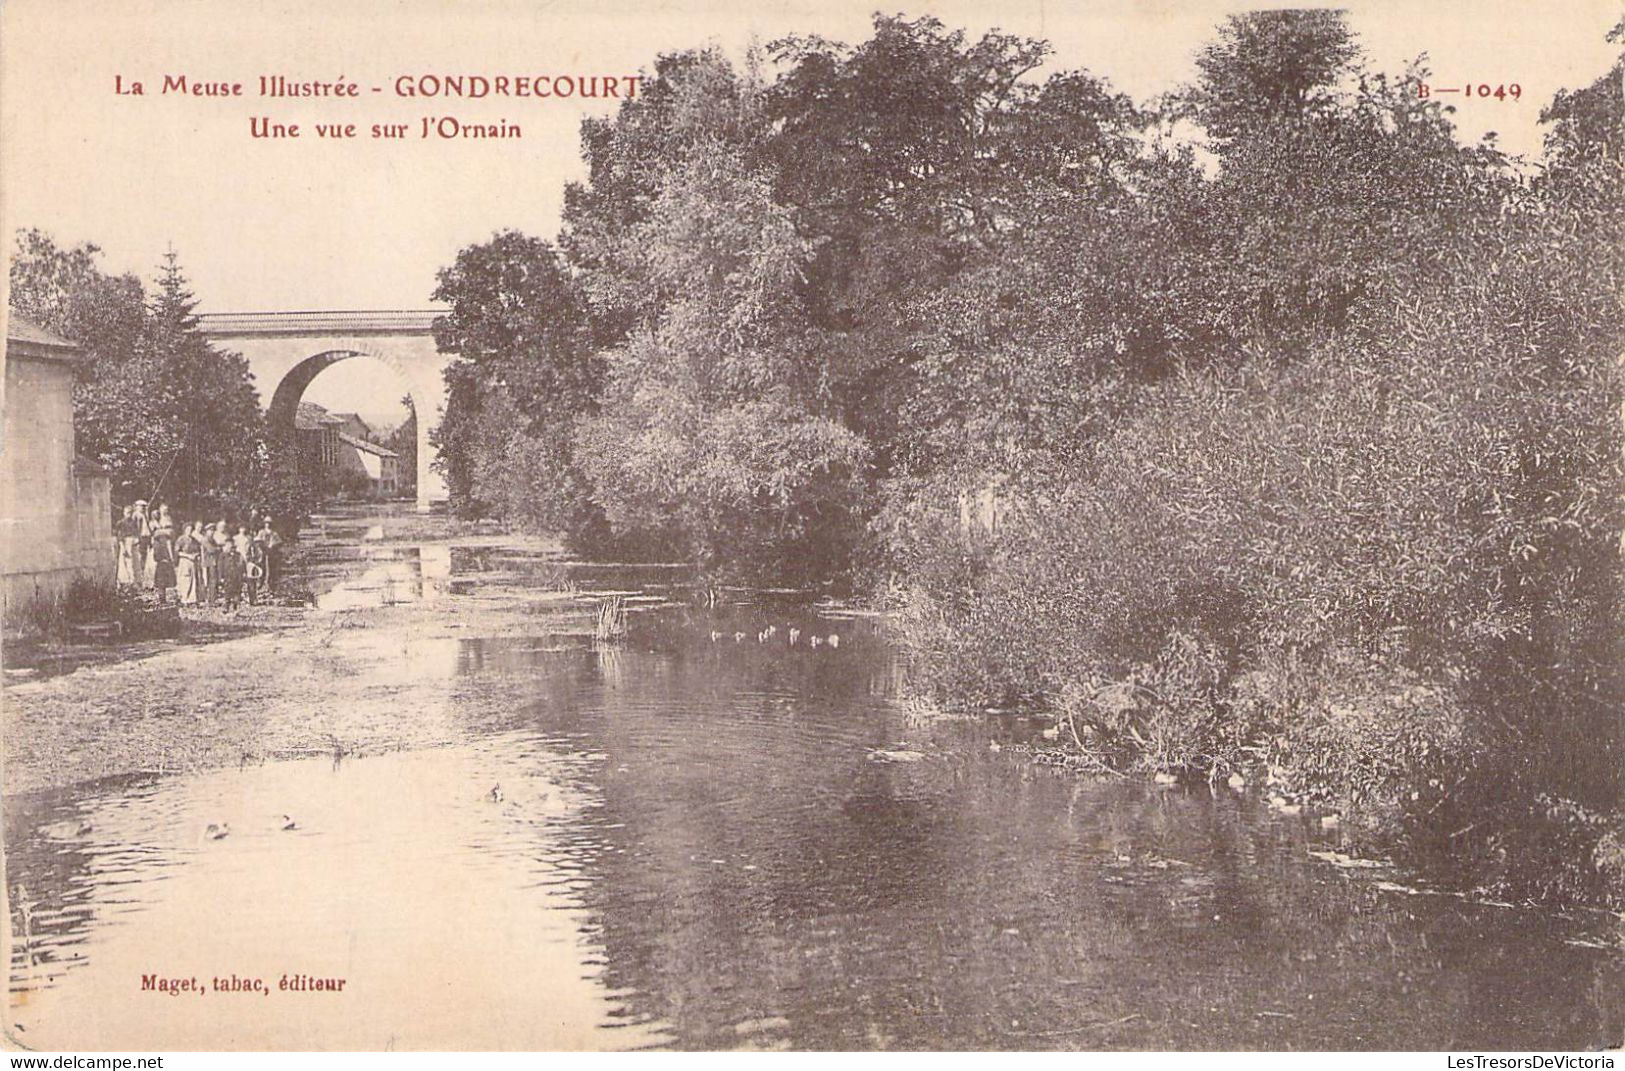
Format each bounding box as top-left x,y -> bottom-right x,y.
0,314 -> 115,622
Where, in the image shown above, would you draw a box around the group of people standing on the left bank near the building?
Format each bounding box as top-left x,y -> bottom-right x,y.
114,501 -> 283,609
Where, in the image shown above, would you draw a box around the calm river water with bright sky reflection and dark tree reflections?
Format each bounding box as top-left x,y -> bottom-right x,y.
5,516 -> 1625,1051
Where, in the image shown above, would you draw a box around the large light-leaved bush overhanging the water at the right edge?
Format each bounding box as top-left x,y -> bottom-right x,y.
881,196 -> 1625,894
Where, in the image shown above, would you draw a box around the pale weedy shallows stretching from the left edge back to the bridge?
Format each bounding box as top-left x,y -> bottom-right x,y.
0,510 -> 592,795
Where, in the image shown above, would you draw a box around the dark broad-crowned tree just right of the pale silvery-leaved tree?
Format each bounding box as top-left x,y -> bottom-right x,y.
764,16 -> 1141,478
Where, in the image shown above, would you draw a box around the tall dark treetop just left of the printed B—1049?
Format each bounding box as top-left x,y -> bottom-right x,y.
1175,10 -> 1515,364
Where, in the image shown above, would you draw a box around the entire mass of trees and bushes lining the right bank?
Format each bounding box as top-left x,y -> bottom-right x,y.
439,11 -> 1625,897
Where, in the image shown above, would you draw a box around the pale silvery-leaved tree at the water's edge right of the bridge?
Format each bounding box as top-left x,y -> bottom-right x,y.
569,54 -> 868,572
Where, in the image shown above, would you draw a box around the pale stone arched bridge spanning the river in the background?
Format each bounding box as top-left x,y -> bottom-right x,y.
198,309 -> 450,510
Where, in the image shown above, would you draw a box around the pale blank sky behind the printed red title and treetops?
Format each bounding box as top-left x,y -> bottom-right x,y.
0,0 -> 1622,425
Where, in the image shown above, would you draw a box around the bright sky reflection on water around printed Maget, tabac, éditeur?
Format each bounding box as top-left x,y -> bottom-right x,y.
10,735 -> 663,1050
